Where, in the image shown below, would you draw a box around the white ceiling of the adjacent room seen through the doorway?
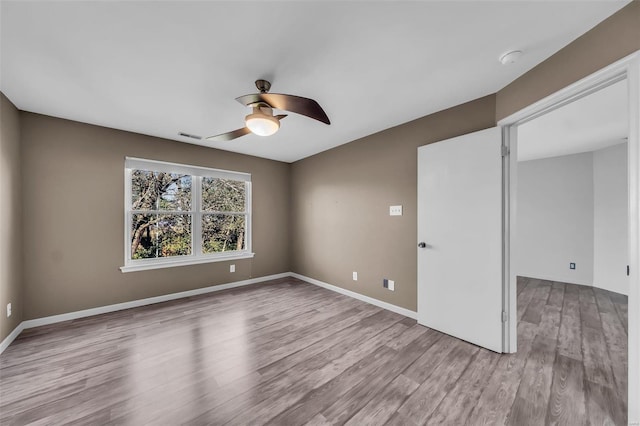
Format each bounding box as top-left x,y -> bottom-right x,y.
518,80 -> 629,161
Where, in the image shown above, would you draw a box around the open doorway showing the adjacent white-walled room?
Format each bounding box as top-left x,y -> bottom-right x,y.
512,80 -> 629,424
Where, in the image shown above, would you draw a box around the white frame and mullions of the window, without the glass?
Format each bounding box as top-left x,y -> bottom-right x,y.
120,157 -> 254,272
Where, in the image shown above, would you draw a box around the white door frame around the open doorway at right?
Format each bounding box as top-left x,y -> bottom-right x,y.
498,50 -> 640,424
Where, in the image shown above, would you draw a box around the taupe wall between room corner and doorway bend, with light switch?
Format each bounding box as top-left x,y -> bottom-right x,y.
291,95 -> 495,311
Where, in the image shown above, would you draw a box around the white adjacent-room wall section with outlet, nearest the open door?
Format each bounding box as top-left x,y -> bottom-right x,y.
515,152 -> 594,285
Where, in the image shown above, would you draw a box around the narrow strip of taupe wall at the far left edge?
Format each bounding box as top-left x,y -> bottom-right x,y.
0,93 -> 23,341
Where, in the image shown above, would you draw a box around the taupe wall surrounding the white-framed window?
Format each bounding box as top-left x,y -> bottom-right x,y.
21,112 -> 290,319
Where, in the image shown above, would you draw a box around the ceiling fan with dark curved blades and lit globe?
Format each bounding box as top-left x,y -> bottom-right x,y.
204,80 -> 331,142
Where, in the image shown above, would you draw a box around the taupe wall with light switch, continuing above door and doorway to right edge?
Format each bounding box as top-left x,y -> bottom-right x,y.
291,1 -> 640,310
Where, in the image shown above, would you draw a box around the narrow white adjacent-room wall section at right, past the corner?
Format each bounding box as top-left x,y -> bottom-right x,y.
593,143 -> 629,294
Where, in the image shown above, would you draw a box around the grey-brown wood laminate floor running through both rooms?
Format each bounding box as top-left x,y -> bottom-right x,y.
0,278 -> 627,425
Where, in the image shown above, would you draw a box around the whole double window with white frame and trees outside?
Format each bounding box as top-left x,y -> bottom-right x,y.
120,158 -> 253,272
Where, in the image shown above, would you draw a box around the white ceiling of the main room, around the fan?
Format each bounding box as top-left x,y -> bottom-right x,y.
0,0 -> 628,162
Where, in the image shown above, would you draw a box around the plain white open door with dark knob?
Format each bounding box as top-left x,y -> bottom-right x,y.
418,127 -> 502,352
